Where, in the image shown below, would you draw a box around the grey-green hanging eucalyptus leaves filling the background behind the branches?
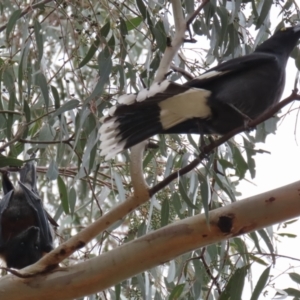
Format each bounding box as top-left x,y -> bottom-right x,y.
0,0 -> 300,300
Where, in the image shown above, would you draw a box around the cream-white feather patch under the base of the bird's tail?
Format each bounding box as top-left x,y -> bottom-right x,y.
158,88 -> 211,129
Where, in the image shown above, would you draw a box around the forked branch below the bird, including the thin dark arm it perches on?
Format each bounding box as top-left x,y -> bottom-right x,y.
8,91 -> 300,277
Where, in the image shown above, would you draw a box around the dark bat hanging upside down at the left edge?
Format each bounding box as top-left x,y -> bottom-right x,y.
0,161 -> 58,269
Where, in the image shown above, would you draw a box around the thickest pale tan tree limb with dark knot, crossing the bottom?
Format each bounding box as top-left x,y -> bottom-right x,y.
0,181 -> 300,300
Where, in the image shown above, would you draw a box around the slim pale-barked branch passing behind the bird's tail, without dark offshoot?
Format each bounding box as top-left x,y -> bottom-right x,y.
4,0 -> 197,277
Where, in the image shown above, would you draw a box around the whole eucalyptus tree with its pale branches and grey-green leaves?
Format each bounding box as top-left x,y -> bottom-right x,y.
0,0 -> 300,300
